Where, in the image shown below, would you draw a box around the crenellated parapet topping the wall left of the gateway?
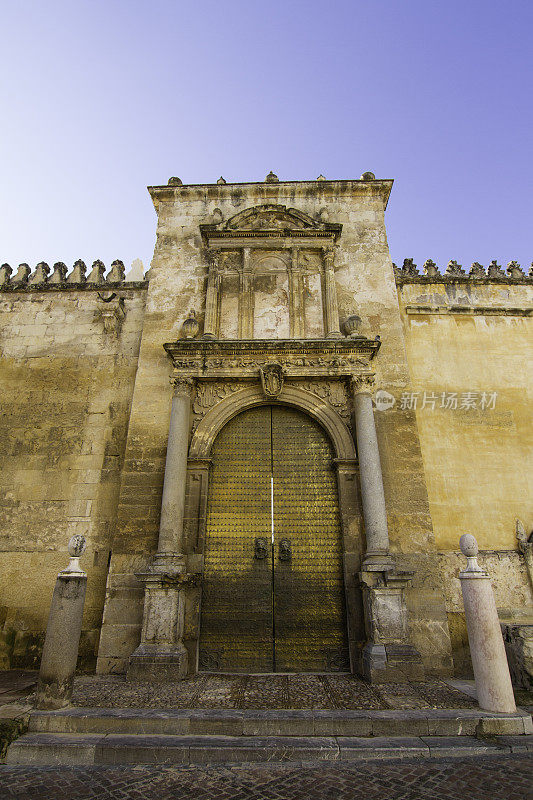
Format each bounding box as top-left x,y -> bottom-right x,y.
0,259 -> 148,292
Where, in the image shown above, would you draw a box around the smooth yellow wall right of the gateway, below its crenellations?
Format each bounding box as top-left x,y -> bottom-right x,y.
400,281 -> 533,673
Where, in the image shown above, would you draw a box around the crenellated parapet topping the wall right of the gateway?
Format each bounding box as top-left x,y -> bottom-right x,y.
392,258 -> 533,286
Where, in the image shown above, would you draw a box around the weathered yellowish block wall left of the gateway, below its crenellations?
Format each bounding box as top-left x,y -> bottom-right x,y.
0,287 -> 145,668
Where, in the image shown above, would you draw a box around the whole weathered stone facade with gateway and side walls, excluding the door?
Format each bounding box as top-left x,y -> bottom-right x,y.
0,173 -> 533,680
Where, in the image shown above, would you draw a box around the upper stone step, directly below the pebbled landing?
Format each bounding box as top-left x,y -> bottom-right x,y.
29,708 -> 533,737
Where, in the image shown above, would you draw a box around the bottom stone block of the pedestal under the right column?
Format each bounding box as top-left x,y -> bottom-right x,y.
359,642 -> 425,683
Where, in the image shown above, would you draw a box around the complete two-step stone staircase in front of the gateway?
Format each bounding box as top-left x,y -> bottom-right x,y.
7,708 -> 533,765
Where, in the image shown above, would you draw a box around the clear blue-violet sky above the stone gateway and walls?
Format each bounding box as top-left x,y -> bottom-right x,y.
0,0 -> 533,276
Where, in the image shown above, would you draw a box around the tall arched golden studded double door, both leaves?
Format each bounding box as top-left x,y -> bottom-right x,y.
199,406 -> 349,672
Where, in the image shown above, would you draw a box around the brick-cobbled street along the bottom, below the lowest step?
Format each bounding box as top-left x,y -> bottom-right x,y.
0,755 -> 533,800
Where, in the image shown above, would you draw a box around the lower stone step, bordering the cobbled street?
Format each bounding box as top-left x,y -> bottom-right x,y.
6,733 -> 533,765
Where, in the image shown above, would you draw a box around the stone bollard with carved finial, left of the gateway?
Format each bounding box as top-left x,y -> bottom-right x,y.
36,536 -> 87,709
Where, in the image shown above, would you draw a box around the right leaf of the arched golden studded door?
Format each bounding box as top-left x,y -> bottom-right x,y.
272,406 -> 349,672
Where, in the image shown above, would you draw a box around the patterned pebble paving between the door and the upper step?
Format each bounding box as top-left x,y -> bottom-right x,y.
68,674 -> 476,710
